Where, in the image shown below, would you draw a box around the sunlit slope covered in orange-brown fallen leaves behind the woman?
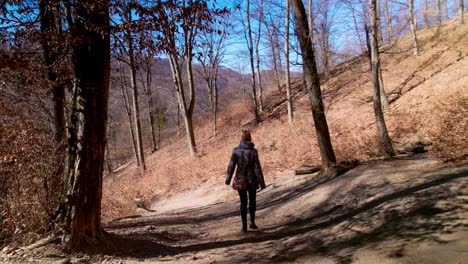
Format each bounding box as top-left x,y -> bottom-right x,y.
103,18 -> 468,221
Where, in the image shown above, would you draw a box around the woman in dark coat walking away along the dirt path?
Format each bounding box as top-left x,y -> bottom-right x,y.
226,130 -> 265,232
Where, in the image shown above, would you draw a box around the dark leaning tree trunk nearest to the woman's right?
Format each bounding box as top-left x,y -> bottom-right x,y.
291,0 -> 336,171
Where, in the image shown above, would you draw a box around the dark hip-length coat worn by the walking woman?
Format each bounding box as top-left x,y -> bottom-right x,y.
226,141 -> 265,190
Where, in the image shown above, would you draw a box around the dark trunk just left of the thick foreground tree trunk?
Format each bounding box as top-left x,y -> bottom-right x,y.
39,1 -> 65,143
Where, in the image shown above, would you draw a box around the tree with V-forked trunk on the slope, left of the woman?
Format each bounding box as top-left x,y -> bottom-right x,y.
148,1 -> 226,158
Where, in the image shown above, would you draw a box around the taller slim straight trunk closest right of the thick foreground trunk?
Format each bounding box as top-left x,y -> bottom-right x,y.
126,10 -> 146,171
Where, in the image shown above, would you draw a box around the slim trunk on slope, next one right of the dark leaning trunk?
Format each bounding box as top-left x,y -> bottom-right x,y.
370,0 -> 395,158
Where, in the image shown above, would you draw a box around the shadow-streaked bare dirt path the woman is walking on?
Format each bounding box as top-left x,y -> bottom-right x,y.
0,154 -> 468,264
